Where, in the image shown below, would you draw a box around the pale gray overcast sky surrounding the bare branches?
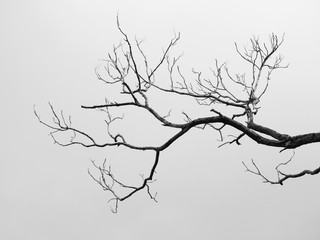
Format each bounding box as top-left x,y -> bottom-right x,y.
0,0 -> 320,240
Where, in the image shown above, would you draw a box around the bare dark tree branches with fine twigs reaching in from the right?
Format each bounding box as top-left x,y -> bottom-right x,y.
34,20 -> 320,214
